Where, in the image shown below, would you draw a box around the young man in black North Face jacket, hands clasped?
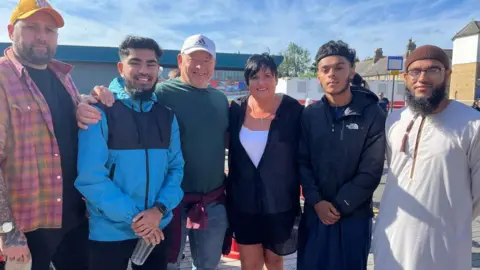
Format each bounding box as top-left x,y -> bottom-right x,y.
297,41 -> 385,270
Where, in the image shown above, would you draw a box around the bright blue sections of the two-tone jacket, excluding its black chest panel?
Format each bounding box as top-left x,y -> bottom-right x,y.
75,79 -> 184,241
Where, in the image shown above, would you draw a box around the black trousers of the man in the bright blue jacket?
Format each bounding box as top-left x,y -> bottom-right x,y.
89,226 -> 170,270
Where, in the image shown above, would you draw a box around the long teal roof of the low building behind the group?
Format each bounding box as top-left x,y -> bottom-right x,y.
0,42 -> 283,70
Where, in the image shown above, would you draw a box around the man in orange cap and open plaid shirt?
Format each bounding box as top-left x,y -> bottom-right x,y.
0,0 -> 88,270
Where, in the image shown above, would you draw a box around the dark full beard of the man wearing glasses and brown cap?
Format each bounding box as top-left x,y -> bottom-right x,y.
405,82 -> 447,116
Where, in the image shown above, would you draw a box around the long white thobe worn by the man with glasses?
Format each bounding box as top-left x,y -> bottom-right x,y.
373,101 -> 480,270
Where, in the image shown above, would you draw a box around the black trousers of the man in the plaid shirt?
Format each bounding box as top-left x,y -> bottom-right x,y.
25,218 -> 88,270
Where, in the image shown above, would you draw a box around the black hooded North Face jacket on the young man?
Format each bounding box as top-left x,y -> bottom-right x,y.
299,87 -> 386,218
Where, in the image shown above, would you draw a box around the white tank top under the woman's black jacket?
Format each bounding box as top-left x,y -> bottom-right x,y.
240,126 -> 268,167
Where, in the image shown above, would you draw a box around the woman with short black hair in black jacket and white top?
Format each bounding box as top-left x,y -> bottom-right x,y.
227,54 -> 303,270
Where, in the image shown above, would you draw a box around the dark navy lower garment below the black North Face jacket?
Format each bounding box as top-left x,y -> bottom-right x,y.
297,206 -> 372,270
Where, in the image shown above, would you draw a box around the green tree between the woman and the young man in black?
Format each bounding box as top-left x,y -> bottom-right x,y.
278,42 -> 311,77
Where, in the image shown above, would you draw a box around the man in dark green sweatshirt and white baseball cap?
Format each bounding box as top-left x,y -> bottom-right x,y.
77,35 -> 229,270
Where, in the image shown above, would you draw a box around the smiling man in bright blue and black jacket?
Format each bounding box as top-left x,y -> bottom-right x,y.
75,36 -> 184,270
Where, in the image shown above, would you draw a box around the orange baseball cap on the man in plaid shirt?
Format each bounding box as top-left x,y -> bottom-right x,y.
10,0 -> 65,28
